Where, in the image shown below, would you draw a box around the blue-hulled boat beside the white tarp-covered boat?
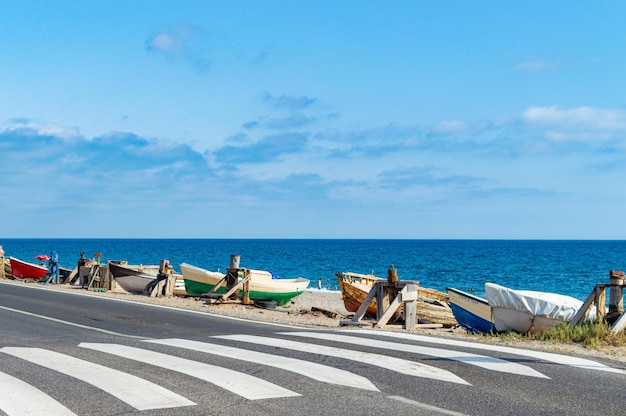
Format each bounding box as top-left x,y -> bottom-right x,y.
446,287 -> 496,334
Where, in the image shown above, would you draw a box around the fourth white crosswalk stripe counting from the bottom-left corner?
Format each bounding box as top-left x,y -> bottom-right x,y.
146,338 -> 379,391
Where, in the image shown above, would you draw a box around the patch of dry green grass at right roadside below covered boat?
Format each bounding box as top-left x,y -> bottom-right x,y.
482,322 -> 626,349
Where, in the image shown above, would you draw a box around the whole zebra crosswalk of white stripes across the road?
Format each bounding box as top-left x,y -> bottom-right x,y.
0,330 -> 626,416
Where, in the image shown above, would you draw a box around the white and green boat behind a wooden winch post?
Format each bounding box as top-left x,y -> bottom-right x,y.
180,263 -> 309,306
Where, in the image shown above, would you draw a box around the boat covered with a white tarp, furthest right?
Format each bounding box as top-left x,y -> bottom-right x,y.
485,283 -> 583,334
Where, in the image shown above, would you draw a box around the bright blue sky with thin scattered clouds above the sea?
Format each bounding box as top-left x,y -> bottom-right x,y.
0,0 -> 626,239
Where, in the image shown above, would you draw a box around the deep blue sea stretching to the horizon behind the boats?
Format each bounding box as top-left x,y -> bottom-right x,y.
0,239 -> 626,300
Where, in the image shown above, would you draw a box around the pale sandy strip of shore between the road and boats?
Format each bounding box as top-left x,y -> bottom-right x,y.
2,279 -> 626,369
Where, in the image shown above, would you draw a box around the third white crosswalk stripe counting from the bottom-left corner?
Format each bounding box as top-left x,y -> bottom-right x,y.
79,343 -> 300,400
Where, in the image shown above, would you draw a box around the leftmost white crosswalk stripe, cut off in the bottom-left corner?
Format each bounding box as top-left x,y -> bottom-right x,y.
0,372 -> 76,416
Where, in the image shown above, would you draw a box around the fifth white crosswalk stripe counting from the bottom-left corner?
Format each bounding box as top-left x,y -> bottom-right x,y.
213,335 -> 470,385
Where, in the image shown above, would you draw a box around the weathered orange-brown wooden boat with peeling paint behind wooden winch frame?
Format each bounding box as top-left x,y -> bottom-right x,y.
335,272 -> 457,328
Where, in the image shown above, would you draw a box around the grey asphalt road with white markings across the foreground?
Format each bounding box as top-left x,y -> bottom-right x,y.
0,283 -> 626,416
